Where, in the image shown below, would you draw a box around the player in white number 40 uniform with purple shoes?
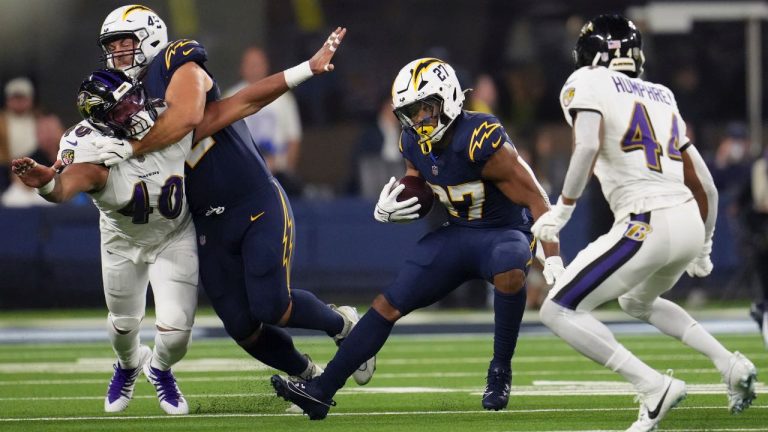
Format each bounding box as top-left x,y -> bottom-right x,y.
12,69 -> 198,414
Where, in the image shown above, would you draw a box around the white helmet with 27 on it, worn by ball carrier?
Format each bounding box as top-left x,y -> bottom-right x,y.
392,58 -> 464,154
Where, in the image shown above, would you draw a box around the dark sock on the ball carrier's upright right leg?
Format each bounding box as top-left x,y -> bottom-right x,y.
491,287 -> 526,369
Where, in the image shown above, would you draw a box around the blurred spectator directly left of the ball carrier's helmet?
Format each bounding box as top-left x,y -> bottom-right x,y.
348,92 -> 403,199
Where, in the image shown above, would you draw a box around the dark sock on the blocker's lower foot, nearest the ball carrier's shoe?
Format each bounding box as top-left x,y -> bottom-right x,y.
241,324 -> 308,375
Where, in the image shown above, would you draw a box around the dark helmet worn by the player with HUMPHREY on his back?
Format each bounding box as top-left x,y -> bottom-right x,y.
573,15 -> 645,77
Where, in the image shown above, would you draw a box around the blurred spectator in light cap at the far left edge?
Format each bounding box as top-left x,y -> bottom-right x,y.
0,77 -> 37,192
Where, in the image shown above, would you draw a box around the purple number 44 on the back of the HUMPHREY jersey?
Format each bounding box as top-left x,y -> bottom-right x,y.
621,102 -> 683,173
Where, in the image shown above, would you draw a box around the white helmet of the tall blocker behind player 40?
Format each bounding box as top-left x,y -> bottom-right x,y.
99,5 -> 168,78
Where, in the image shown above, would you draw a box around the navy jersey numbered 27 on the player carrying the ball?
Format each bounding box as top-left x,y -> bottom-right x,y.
400,111 -> 531,231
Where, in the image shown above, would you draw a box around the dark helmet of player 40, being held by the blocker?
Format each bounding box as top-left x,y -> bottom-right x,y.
77,69 -> 157,138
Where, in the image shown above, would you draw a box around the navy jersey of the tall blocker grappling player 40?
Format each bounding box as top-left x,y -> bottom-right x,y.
142,39 -> 271,214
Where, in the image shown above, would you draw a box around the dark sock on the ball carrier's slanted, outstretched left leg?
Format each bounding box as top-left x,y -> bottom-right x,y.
317,308 -> 395,398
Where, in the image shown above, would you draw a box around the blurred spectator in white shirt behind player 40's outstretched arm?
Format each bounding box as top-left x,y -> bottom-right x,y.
226,46 -> 301,195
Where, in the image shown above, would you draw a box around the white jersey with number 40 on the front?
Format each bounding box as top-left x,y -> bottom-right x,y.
59,121 -> 192,263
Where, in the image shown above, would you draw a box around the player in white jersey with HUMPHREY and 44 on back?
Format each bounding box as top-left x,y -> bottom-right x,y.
532,15 -> 756,431
